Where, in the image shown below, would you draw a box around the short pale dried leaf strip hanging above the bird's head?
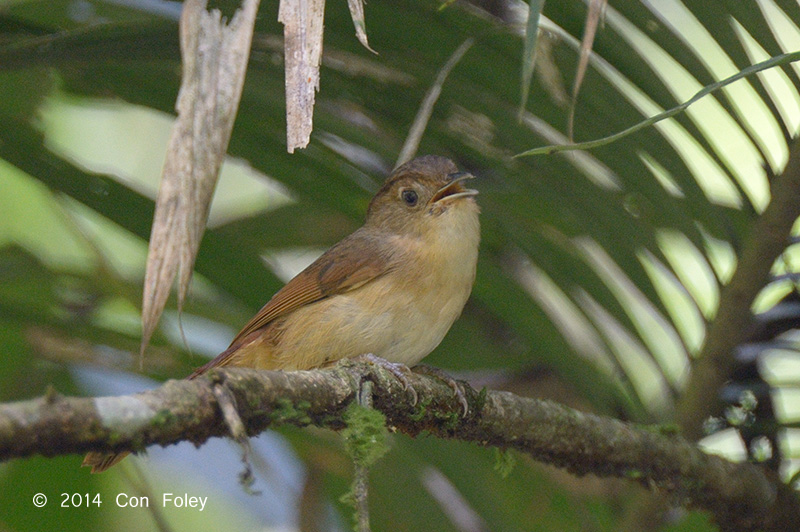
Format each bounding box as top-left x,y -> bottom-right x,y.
278,0 -> 325,153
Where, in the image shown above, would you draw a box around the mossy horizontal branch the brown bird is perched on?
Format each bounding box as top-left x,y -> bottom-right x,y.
0,362 -> 800,530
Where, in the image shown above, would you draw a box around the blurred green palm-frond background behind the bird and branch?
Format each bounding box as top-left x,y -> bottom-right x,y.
0,0 -> 800,532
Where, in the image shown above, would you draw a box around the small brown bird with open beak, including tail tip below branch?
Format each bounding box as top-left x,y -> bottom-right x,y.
83,155 -> 480,473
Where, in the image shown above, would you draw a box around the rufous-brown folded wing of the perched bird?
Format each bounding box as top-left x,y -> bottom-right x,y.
189,230 -> 391,378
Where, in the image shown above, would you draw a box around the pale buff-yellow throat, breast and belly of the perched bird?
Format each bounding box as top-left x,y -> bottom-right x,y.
257,202 -> 480,369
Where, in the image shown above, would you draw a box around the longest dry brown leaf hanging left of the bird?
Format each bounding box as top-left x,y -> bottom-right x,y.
141,0 -> 259,353
